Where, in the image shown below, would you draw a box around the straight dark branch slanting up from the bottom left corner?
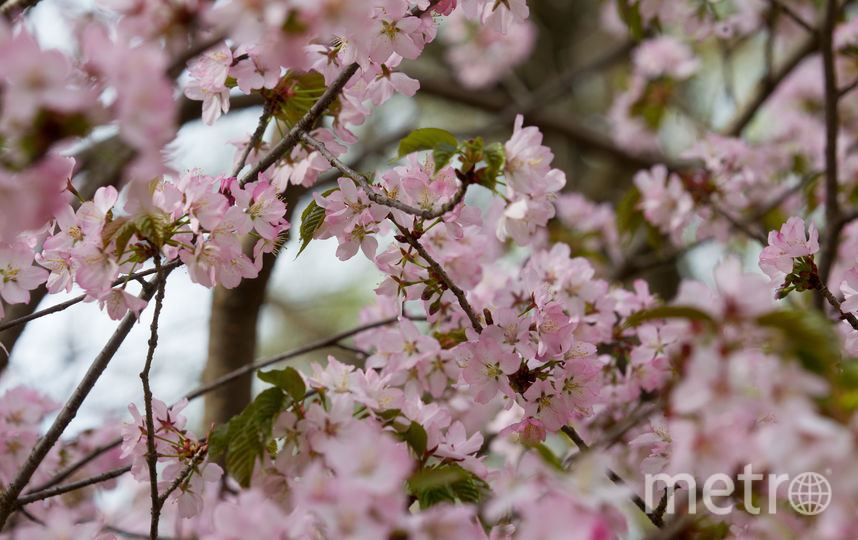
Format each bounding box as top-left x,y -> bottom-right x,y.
0,271 -> 169,530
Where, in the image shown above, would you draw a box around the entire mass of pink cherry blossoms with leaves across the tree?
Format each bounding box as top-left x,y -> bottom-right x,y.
5,0 -> 858,540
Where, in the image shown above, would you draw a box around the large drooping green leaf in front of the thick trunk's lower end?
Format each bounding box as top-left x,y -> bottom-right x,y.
209,388 -> 286,487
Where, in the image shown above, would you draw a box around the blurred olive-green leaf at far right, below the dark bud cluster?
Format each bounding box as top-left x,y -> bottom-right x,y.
757,309 -> 840,375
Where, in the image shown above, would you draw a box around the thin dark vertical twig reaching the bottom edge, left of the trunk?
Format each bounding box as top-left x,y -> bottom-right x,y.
140,252 -> 166,540
